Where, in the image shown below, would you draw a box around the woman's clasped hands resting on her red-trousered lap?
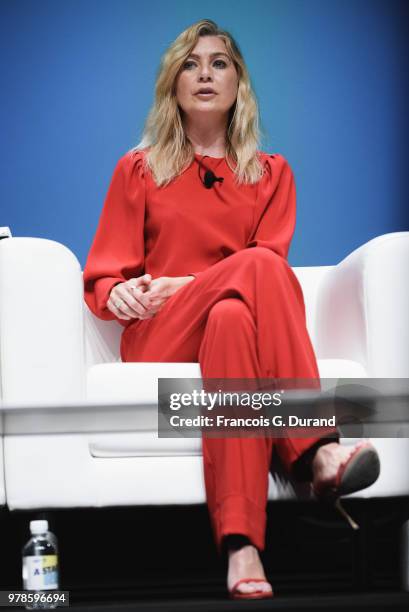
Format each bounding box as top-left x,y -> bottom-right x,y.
107,274 -> 194,321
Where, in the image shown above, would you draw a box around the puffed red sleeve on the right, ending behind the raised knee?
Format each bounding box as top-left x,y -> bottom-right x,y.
246,155 -> 296,259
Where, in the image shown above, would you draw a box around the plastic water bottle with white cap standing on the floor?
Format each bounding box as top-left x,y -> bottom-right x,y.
23,521 -> 59,610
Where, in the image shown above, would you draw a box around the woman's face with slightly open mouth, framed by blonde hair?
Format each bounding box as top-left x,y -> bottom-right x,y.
176,36 -> 239,119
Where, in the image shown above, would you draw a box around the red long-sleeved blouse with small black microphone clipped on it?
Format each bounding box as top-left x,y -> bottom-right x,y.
83,151 -> 295,327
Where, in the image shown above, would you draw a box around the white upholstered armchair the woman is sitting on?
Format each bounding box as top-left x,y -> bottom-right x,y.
0,232 -> 409,509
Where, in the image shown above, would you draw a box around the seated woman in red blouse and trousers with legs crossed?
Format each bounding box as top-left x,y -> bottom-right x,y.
84,20 -> 379,598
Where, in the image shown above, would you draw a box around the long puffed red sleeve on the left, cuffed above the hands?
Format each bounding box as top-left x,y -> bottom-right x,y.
83,151 -> 145,321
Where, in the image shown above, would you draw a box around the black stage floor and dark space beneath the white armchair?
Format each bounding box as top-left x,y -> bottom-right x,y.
0,498 -> 409,612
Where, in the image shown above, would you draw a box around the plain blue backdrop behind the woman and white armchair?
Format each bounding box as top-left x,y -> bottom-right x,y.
0,0 -> 409,265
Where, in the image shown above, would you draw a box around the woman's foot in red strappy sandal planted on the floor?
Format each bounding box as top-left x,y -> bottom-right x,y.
227,543 -> 272,593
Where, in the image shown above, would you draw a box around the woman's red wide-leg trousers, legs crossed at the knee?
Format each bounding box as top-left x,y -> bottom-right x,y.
121,247 -> 334,551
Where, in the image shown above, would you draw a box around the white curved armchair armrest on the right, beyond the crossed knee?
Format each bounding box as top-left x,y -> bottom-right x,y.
316,232 -> 409,378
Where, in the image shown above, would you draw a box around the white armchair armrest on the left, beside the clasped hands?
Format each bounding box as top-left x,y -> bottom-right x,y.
0,238 -> 85,404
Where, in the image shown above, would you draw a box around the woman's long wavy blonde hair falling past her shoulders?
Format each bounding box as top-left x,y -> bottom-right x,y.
131,19 -> 263,187
